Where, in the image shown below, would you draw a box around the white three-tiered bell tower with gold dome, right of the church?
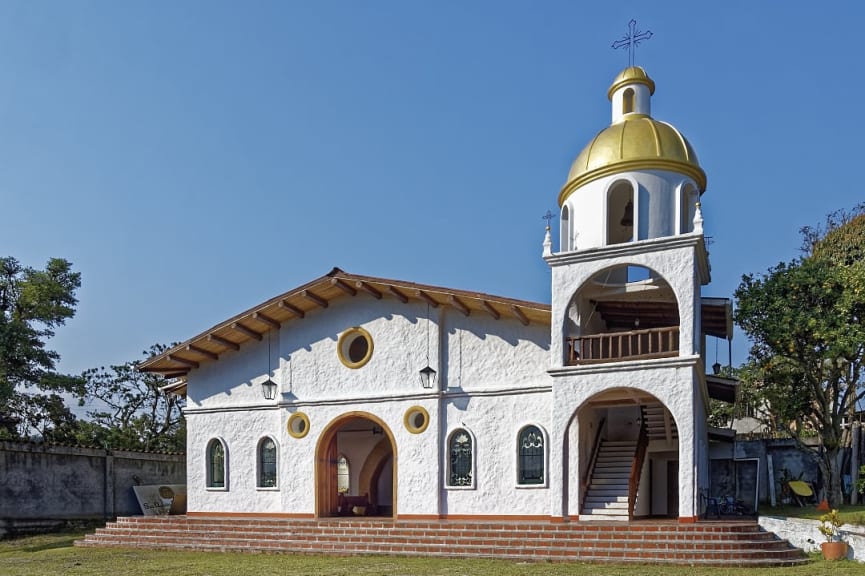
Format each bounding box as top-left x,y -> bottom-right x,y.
544,66 -> 724,520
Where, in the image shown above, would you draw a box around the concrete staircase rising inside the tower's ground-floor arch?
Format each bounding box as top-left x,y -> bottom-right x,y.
580,440 -> 637,521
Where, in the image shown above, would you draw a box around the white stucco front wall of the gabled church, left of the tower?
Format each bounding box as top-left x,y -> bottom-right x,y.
187,294 -> 551,515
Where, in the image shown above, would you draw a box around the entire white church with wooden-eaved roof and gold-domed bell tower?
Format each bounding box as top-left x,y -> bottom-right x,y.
141,67 -> 735,523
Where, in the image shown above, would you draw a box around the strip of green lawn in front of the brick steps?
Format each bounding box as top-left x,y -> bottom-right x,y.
0,533 -> 863,576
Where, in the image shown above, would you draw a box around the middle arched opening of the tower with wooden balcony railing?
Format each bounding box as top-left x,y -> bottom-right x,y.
564,265 -> 679,365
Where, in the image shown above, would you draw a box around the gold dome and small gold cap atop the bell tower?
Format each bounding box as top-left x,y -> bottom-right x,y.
559,66 -> 706,206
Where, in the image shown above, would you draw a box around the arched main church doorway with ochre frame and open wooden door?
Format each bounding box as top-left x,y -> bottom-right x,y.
315,412 -> 396,518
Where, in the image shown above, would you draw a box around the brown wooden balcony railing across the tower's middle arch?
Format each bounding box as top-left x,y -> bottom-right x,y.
565,326 -> 679,366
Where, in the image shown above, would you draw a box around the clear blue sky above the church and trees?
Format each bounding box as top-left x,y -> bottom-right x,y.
0,0 -> 865,392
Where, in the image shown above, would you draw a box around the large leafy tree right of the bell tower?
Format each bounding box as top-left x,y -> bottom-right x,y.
735,205 -> 865,506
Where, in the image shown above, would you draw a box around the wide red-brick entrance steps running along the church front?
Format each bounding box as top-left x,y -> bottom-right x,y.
76,516 -> 808,566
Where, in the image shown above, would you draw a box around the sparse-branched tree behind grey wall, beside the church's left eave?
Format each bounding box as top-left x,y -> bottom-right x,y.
78,344 -> 186,452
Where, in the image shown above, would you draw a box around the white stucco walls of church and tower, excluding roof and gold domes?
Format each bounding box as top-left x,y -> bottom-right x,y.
164,66 -> 724,521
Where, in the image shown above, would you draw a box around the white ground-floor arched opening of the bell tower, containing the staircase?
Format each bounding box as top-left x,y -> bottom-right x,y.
565,387 -> 679,520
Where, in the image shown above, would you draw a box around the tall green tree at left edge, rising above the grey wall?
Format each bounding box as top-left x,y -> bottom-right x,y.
0,256 -> 81,439
